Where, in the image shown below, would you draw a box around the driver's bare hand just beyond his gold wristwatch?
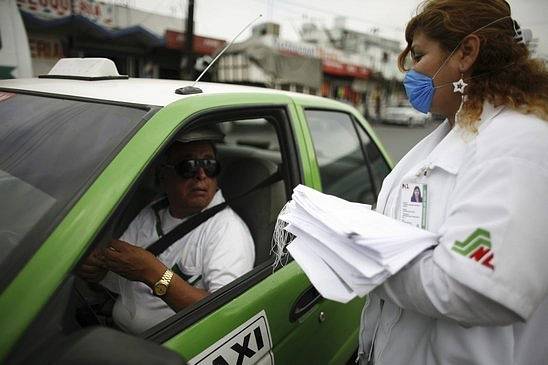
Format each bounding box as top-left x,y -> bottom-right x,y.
103,240 -> 167,287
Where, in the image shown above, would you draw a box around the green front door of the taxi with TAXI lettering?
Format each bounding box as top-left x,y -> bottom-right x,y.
146,99 -> 363,364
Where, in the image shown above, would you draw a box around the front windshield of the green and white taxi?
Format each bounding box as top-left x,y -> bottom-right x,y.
0,92 -> 151,272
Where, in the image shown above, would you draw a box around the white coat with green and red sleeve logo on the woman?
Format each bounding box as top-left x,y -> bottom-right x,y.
360,103 -> 548,365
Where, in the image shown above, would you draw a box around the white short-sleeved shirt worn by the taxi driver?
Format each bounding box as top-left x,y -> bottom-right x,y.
102,190 -> 255,333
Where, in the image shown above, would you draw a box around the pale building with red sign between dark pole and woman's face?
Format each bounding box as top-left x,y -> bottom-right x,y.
217,18 -> 403,117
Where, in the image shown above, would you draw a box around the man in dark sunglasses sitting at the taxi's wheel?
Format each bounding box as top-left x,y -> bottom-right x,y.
79,127 -> 255,333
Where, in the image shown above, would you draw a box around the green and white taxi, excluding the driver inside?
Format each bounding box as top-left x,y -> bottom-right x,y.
0,60 -> 392,364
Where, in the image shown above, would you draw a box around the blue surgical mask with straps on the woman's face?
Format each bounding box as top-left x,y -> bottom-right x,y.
403,16 -> 510,114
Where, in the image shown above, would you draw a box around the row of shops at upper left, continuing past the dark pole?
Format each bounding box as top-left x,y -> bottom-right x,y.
17,0 -> 225,79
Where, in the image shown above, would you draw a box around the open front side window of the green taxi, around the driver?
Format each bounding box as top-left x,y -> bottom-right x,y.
71,107 -> 295,338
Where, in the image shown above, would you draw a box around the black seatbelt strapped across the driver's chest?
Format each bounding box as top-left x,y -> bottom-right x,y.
147,170 -> 282,256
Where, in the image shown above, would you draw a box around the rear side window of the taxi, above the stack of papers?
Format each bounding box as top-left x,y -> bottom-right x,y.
305,110 -> 386,204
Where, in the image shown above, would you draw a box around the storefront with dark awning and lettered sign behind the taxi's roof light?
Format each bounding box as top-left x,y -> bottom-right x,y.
17,0 -> 164,76
